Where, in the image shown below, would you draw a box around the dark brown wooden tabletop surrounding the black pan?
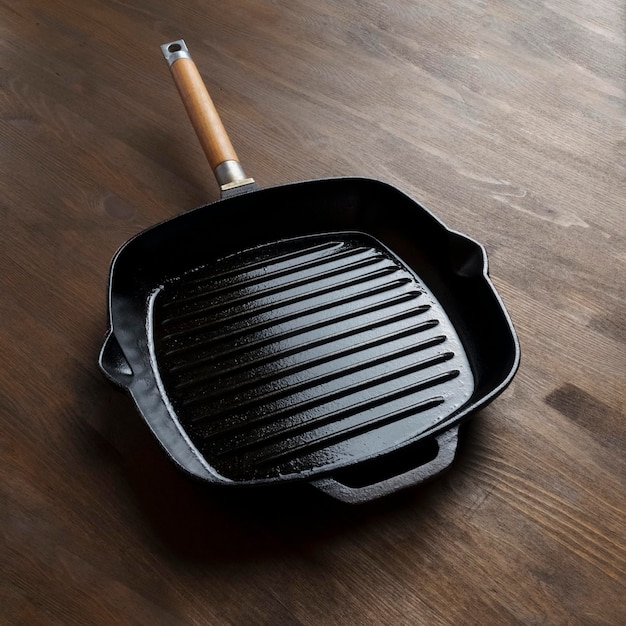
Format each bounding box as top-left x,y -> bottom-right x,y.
0,0 -> 626,625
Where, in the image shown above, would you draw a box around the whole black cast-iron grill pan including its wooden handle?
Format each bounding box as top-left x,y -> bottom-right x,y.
99,40 -> 519,502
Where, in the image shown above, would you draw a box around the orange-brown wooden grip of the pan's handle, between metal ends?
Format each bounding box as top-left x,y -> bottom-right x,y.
170,58 -> 239,171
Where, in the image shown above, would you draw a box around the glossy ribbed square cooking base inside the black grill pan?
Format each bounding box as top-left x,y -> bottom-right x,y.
153,235 -> 473,480
